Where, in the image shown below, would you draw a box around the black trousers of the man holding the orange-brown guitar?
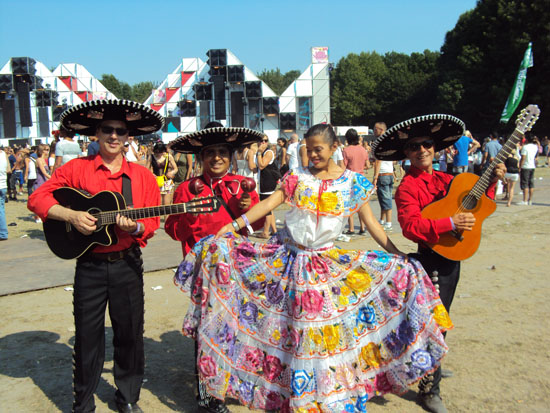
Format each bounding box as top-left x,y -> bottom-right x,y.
409,248 -> 460,395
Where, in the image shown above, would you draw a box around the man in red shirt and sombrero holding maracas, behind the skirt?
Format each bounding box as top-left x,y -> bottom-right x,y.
164,122 -> 264,413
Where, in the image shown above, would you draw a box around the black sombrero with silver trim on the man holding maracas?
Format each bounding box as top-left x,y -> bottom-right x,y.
170,127 -> 264,153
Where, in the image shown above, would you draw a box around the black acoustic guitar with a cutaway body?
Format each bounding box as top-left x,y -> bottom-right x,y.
44,187 -> 220,260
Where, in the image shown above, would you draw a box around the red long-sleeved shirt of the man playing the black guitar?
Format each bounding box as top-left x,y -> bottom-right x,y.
27,155 -> 160,253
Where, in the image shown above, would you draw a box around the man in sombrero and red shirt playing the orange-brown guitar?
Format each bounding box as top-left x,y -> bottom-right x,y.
373,115 -> 506,413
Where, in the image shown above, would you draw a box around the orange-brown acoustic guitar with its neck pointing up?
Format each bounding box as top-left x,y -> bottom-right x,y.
421,105 -> 540,261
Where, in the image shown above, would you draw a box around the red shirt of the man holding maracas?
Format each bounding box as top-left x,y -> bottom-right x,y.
164,173 -> 264,256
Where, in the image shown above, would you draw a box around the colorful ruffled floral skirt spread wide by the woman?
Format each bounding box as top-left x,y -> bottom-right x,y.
174,230 -> 452,413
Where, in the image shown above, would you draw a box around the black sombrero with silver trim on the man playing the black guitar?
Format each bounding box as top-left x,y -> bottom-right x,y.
60,99 -> 164,136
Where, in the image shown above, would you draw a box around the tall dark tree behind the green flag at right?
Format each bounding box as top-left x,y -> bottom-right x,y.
438,0 -> 550,132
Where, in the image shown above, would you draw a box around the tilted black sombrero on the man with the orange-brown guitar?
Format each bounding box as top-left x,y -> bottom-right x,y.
371,114 -> 466,161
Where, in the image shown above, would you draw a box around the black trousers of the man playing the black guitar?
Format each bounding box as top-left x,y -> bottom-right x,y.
73,248 -> 145,412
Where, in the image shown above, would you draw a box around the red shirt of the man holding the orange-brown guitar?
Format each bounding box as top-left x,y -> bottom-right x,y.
395,165 -> 495,248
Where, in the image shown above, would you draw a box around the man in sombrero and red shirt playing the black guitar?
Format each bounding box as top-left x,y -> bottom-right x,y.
28,100 -> 163,412
